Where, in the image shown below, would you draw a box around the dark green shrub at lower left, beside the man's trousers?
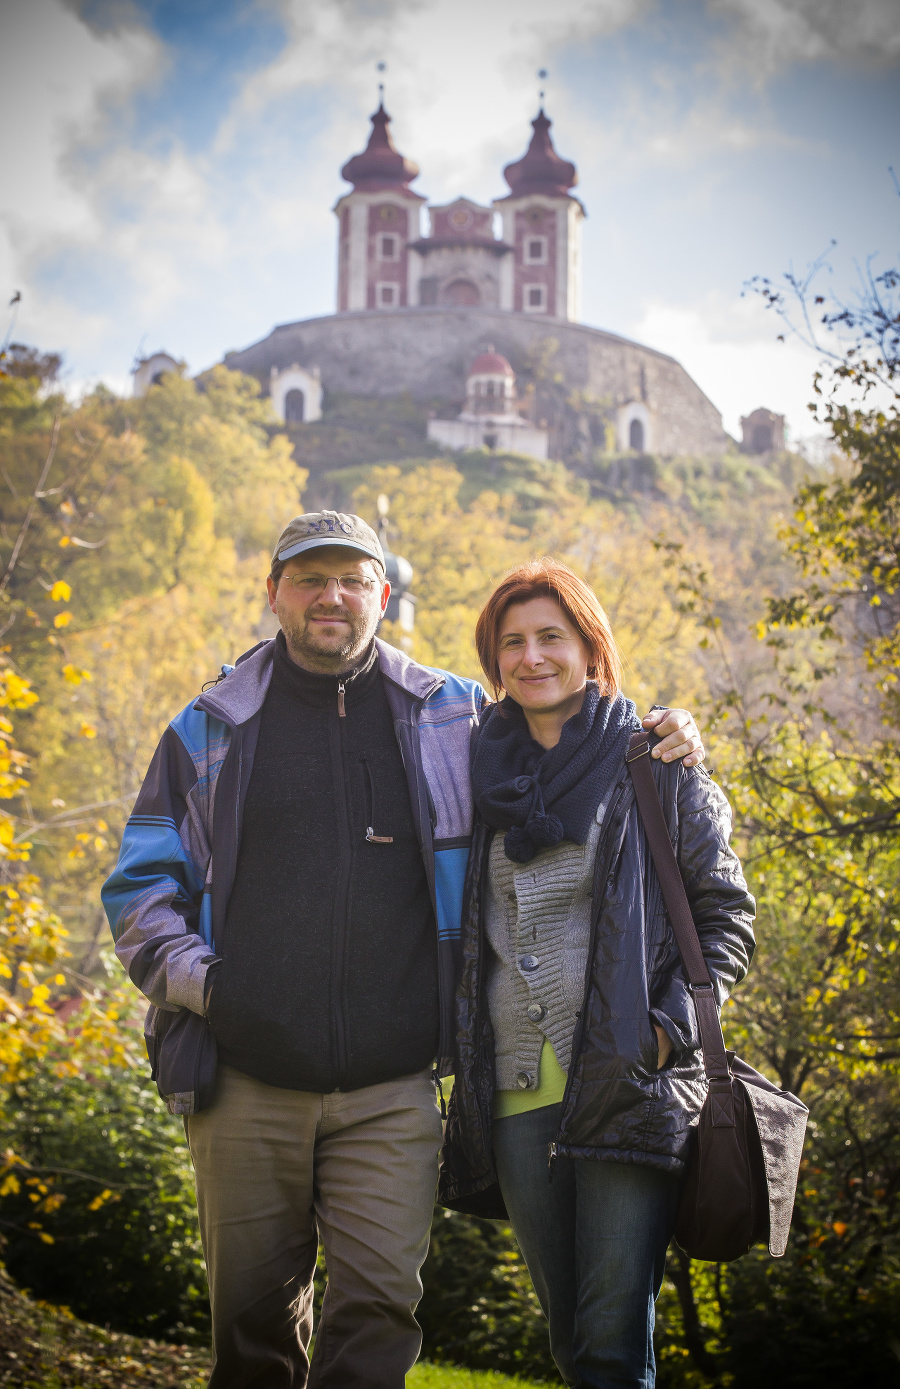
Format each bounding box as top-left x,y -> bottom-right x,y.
0,1068 -> 210,1340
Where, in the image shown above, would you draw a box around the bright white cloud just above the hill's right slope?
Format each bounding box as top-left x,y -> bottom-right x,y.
632,294 -> 818,440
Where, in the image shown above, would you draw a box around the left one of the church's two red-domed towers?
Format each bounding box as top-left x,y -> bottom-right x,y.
335,103 -> 425,314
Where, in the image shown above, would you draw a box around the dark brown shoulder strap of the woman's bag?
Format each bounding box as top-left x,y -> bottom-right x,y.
625,732 -> 731,1081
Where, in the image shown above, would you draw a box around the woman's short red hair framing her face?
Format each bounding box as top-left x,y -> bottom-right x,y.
475,558 -> 622,699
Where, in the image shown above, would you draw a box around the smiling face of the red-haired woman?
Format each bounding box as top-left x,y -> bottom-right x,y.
499,597 -> 589,718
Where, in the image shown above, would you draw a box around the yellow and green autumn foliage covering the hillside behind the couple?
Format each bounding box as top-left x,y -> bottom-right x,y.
0,304 -> 900,1389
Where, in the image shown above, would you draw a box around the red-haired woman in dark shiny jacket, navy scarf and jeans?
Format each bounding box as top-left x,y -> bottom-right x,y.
439,560 -> 754,1389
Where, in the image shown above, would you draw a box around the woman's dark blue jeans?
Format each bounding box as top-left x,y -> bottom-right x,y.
493,1104 -> 679,1389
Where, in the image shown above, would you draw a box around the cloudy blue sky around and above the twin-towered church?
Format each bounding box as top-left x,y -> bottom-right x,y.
0,0 -> 900,440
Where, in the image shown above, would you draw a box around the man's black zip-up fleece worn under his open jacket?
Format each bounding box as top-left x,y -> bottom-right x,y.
208,633 -> 438,1092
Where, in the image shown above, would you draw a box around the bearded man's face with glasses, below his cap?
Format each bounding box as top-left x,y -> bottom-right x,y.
267,546 -> 390,675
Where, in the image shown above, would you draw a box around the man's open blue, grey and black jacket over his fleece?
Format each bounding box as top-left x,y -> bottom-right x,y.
101,640 -> 488,1114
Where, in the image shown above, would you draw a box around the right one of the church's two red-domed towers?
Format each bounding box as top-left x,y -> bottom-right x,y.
493,107 -> 585,322
